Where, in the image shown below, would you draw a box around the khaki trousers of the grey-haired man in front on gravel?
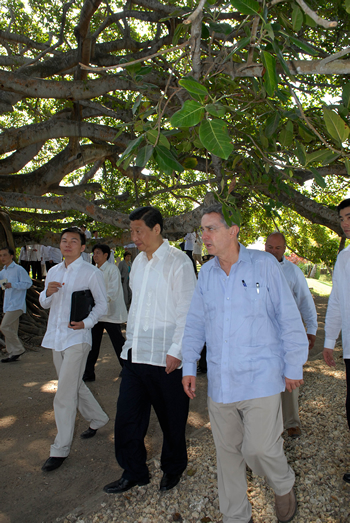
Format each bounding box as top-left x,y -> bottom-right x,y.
208,394 -> 295,523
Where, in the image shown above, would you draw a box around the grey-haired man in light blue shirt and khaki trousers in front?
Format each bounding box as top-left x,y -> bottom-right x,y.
182,205 -> 308,523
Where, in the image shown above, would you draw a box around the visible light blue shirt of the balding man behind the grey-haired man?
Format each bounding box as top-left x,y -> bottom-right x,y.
280,256 -> 318,334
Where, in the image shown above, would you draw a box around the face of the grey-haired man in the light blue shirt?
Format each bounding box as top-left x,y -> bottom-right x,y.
201,212 -> 232,258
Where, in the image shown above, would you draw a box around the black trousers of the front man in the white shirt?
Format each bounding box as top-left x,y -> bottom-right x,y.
114,350 -> 189,481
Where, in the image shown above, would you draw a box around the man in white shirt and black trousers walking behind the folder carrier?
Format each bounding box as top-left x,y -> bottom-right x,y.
83,243 -> 128,381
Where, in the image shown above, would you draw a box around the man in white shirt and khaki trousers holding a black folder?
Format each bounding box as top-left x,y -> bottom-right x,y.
40,227 -> 108,472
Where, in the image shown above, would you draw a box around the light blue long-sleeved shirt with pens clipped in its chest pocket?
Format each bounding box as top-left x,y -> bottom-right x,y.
182,244 -> 309,403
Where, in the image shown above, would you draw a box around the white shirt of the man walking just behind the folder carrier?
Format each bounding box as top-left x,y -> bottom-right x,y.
98,261 -> 128,323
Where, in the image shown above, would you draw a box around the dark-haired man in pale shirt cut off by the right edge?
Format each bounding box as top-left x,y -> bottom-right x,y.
323,198 -> 350,483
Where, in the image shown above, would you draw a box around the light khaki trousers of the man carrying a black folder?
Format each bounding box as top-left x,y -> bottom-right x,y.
50,343 -> 109,458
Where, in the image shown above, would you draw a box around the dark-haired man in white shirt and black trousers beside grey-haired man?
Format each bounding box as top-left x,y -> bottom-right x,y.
104,207 -> 196,494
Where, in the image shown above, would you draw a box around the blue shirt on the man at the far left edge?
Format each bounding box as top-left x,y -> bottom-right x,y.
0,261 -> 33,312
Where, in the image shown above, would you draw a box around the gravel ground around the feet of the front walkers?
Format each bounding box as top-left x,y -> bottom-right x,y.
61,347 -> 350,523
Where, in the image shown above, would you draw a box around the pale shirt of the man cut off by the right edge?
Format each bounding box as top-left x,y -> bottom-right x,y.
324,246 -> 350,359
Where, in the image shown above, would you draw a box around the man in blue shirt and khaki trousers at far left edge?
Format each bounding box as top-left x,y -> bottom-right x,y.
0,247 -> 32,363
